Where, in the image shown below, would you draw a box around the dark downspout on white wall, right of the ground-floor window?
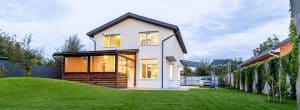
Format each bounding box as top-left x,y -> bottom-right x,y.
161,30 -> 178,88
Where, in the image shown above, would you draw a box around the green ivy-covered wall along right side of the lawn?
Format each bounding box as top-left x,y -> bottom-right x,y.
234,53 -> 296,99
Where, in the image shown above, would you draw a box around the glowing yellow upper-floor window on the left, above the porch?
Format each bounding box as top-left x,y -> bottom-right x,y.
103,34 -> 121,47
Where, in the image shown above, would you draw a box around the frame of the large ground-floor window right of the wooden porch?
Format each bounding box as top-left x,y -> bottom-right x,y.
140,58 -> 159,80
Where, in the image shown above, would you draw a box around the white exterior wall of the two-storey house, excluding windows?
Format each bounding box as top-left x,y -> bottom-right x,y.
94,18 -> 183,88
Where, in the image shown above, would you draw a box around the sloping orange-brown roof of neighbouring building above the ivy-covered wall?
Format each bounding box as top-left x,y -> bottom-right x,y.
240,38 -> 290,67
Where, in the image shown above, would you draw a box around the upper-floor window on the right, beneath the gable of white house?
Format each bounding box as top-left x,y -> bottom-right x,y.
139,32 -> 159,46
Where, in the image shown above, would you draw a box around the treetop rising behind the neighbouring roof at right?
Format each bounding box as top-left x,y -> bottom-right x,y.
253,35 -> 279,56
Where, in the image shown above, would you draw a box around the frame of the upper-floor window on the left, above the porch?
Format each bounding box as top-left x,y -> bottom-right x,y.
102,34 -> 121,48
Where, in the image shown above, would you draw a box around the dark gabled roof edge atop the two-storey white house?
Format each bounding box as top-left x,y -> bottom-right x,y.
87,12 -> 187,53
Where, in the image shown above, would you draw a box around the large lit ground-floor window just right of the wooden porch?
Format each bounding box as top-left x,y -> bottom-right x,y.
141,59 -> 158,79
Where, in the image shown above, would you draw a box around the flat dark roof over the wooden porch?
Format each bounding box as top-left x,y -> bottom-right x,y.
53,49 -> 139,56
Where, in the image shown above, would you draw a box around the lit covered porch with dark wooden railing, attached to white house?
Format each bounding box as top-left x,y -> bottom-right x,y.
53,49 -> 138,88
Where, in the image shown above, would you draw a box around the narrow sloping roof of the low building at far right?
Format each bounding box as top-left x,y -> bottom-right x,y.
240,38 -> 290,66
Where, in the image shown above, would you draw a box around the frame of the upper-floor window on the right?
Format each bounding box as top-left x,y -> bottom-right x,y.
138,31 -> 160,46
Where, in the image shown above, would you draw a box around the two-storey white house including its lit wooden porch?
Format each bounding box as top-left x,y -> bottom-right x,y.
54,13 -> 187,88
